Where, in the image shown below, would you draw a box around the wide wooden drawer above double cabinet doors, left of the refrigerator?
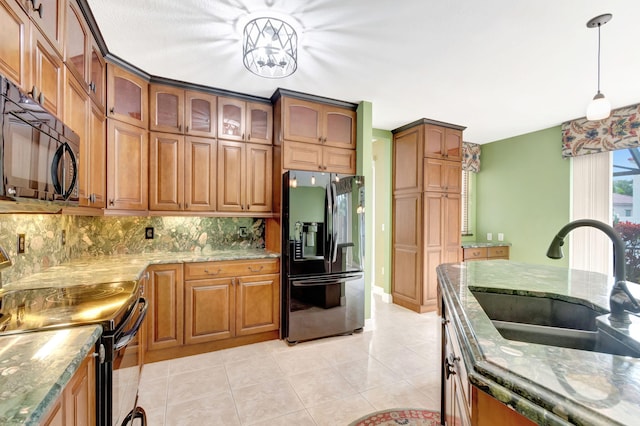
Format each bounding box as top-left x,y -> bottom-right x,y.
184,259 -> 280,280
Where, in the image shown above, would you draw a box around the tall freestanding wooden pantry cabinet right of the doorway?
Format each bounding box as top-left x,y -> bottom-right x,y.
391,119 -> 465,312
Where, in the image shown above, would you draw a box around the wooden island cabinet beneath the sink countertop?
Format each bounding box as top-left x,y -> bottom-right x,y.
440,292 -> 535,426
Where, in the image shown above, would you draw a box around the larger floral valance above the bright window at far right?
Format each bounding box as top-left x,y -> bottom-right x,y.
562,104 -> 640,158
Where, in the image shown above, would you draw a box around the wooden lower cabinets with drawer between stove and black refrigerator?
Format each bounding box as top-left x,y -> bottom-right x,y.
145,259 -> 280,362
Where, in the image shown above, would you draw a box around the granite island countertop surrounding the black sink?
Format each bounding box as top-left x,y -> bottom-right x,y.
438,260 -> 640,425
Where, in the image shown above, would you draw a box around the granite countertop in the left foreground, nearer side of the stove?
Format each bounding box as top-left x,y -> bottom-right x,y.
0,326 -> 102,425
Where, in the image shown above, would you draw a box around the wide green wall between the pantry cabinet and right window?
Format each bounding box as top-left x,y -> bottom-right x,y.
476,126 -> 571,266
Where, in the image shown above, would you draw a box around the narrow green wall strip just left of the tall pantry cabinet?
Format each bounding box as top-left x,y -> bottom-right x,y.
372,129 -> 393,294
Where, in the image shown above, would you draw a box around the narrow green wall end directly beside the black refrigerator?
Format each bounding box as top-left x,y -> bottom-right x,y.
356,101 -> 373,318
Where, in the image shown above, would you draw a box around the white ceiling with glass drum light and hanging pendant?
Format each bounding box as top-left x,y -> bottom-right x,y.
88,0 -> 640,143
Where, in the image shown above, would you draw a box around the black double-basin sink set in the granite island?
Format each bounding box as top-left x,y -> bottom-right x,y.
471,289 -> 640,358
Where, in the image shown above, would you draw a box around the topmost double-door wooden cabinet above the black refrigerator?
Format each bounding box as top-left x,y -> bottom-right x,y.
283,97 -> 356,149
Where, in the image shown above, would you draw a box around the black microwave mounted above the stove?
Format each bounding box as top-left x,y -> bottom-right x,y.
0,76 -> 80,205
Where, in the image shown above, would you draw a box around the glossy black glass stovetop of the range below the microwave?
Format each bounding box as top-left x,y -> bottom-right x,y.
0,281 -> 141,334
